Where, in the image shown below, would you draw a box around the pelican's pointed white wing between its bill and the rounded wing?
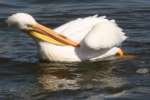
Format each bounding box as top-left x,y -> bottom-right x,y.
54,15 -> 103,42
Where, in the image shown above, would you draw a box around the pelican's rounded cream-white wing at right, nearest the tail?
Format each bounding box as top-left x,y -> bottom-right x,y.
84,19 -> 127,50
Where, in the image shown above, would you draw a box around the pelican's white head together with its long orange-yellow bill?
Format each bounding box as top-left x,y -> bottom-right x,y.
6,13 -> 78,47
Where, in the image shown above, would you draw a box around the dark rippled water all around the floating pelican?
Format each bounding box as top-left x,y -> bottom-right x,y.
0,0 -> 150,100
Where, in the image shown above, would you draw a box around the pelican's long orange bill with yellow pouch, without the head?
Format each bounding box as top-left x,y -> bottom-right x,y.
27,24 -> 79,47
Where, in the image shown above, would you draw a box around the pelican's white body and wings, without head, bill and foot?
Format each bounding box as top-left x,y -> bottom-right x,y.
6,15 -> 127,62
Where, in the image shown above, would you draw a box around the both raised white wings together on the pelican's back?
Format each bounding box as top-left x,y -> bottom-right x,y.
55,16 -> 126,50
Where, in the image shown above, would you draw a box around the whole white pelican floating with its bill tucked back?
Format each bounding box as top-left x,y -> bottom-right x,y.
6,13 -> 127,62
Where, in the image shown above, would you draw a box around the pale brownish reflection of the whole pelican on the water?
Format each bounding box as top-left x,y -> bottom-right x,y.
37,61 -> 126,92
